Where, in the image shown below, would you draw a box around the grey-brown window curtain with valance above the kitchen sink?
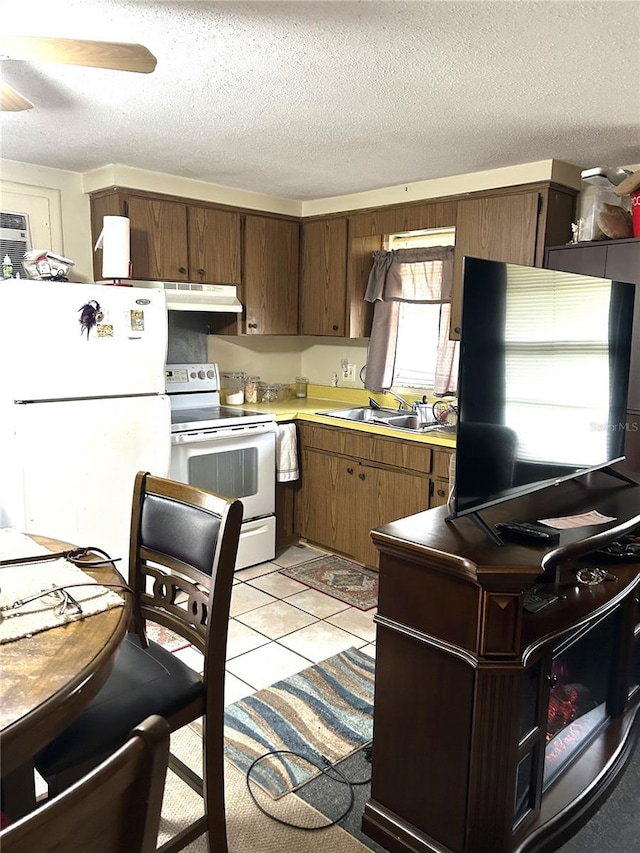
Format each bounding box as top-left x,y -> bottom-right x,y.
364,246 -> 458,394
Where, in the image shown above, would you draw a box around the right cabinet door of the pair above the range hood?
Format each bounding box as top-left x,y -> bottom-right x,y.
187,205 -> 242,284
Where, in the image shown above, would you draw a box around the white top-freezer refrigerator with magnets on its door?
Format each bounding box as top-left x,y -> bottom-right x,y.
0,280 -> 171,569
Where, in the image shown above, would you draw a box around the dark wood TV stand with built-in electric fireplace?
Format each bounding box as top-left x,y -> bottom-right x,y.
363,472 -> 640,853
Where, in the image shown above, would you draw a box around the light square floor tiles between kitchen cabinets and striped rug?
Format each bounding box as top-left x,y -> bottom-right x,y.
175,544 -> 376,705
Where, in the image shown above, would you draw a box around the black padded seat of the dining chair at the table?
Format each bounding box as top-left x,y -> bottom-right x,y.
35,634 -> 204,778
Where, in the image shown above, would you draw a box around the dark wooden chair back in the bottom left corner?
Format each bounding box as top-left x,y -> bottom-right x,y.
0,716 -> 169,853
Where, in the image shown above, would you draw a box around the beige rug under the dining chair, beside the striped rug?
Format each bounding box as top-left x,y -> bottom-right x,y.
158,726 -> 371,853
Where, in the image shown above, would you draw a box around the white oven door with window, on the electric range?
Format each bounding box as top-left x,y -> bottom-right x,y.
169,424 -> 276,522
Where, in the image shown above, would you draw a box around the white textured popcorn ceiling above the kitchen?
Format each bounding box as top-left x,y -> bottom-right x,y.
1,0 -> 640,200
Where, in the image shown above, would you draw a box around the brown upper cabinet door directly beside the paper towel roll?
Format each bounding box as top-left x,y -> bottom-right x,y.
127,196 -> 189,281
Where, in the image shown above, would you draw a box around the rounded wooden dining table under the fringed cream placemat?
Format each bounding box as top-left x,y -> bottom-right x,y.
0,536 -> 132,819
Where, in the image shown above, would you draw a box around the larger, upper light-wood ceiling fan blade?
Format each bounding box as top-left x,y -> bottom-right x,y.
0,36 -> 157,74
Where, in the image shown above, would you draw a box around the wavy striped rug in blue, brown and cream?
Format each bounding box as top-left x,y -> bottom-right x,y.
225,648 -> 375,799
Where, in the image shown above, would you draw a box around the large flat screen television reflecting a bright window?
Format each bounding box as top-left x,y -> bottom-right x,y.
447,257 -> 635,543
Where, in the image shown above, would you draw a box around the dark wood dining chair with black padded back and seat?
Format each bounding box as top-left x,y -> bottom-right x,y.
35,472 -> 242,853
